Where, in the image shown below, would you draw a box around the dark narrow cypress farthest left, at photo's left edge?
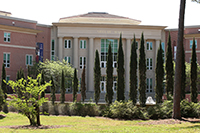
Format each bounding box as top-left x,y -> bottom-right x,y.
1,63 -> 7,99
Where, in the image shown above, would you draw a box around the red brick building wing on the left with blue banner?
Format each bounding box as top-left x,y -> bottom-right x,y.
0,11 -> 51,92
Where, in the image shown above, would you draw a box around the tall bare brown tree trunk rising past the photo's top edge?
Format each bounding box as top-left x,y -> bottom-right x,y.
172,0 -> 186,119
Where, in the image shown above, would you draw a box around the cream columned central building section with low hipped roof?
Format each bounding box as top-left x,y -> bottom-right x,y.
51,12 -> 166,101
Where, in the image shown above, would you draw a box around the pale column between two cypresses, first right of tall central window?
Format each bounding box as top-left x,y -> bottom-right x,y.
125,39 -> 131,92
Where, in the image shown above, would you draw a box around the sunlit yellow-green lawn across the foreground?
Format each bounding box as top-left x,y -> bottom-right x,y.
0,112 -> 200,133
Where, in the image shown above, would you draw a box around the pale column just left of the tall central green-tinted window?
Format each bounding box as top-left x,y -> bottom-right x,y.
87,38 -> 94,91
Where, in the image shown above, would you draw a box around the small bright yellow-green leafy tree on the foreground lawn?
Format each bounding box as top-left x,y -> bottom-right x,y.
8,74 -> 51,126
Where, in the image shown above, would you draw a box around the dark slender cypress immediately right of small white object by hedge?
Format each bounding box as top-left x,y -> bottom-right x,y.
155,41 -> 164,104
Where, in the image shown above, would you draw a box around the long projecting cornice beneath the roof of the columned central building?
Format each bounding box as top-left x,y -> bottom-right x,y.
52,23 -> 167,30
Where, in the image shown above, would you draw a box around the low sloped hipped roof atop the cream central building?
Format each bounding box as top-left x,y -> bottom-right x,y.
59,12 -> 141,25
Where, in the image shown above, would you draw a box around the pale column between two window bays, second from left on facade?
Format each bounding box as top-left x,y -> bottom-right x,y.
73,37 -> 78,69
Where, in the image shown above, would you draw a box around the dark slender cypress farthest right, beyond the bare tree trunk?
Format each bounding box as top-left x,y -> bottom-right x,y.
190,39 -> 198,103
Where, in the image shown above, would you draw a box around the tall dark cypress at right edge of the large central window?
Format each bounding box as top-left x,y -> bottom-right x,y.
117,34 -> 125,101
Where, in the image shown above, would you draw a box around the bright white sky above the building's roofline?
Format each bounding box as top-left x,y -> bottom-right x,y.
0,0 -> 200,28
